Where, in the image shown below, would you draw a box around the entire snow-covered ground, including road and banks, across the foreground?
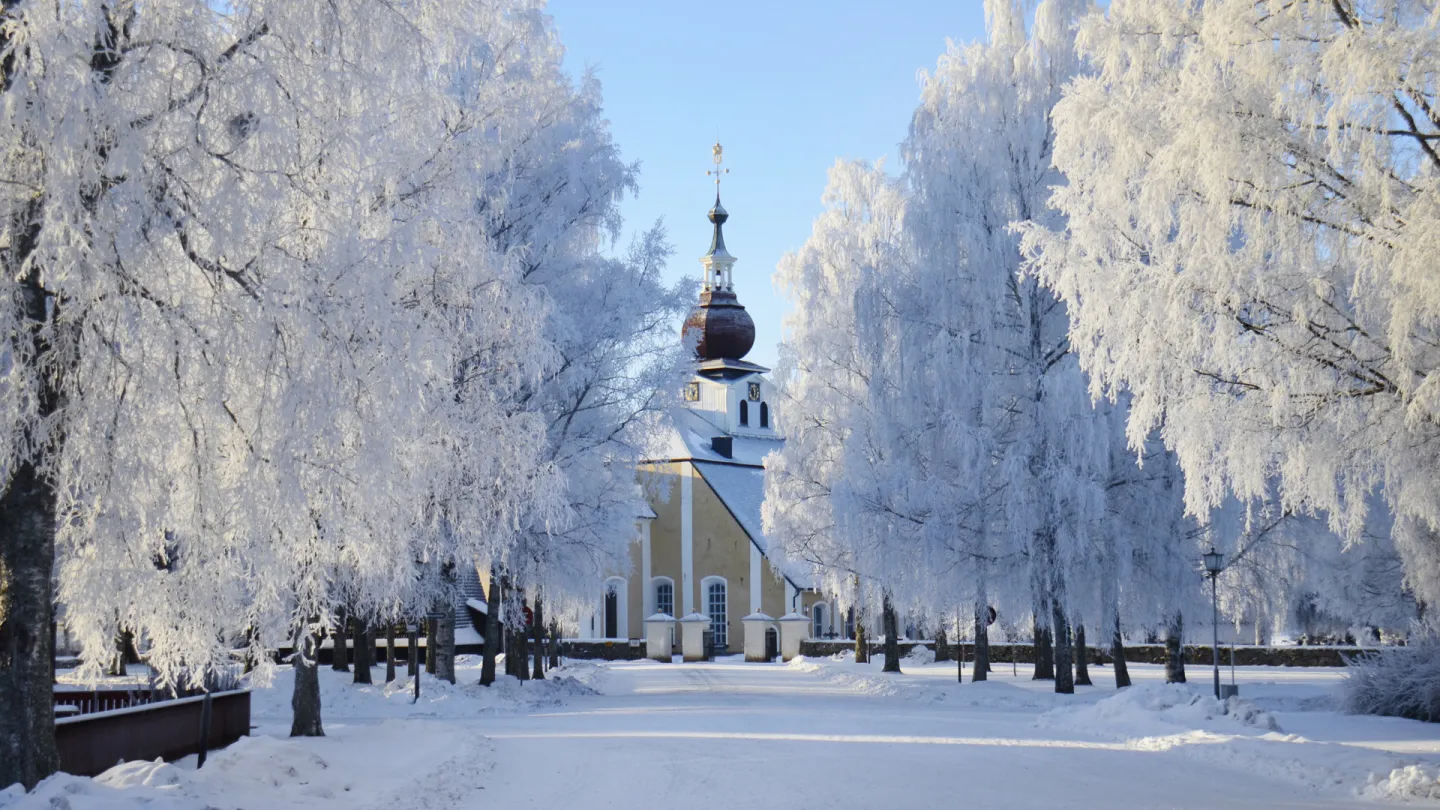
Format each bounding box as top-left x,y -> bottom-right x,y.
8,656 -> 1440,810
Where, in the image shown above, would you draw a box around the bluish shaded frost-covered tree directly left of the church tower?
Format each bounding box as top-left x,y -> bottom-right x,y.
480,56 -> 693,634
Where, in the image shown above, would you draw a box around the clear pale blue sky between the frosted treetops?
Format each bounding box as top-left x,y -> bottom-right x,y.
549,0 -> 985,366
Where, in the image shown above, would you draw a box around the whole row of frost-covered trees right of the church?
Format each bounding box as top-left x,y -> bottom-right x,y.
765,0 -> 1440,692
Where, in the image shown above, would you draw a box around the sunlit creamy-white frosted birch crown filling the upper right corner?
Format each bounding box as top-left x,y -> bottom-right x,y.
1025,0 -> 1440,601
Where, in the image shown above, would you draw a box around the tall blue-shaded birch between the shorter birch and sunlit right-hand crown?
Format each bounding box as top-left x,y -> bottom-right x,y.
903,1 -> 1110,689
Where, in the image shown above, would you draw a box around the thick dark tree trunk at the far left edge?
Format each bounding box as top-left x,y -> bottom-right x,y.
0,458 -> 60,788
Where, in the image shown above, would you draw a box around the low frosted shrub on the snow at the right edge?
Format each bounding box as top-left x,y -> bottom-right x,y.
1341,634 -> 1440,722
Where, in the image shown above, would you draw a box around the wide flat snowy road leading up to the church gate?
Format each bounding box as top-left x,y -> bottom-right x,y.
475,662 -> 1358,810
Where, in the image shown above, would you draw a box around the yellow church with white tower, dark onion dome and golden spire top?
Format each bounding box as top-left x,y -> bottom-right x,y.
579,144 -> 835,653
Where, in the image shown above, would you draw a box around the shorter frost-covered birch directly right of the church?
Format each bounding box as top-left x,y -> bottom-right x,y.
762,161 -> 904,642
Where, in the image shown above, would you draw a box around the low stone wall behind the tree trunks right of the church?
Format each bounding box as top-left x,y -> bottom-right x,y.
801,640 -> 1365,666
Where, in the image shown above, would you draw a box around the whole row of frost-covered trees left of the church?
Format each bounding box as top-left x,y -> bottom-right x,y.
0,0 -> 688,785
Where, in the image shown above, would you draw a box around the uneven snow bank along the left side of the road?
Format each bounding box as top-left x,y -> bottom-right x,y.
0,656 -> 605,810
